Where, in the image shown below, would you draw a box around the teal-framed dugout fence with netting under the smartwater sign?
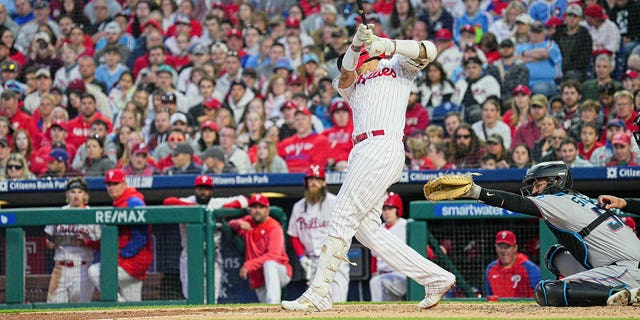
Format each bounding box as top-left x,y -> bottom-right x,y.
407,201 -> 556,301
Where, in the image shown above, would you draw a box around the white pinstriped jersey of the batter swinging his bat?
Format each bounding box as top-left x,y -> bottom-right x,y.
333,54 -> 421,134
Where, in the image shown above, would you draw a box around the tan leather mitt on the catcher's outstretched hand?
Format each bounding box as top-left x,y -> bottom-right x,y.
423,173 -> 478,201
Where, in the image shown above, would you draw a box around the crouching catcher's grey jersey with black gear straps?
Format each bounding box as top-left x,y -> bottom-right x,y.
529,193 -> 640,268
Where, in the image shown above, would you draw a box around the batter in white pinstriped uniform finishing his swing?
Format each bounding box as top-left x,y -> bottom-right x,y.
282,25 -> 455,311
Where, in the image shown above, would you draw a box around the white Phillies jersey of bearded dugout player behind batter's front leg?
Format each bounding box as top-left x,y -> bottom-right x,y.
287,192 -> 336,257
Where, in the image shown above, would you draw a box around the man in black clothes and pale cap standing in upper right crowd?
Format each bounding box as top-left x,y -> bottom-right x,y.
552,3 -> 593,81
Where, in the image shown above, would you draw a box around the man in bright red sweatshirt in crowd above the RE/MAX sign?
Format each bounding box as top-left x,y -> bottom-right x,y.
67,93 -> 113,147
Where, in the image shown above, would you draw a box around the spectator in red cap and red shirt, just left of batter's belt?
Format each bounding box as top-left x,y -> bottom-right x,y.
322,100 -> 356,171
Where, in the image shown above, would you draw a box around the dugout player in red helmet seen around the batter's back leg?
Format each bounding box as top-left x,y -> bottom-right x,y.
369,192 -> 407,302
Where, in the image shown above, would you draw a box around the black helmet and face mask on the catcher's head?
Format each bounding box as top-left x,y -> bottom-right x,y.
520,161 -> 573,197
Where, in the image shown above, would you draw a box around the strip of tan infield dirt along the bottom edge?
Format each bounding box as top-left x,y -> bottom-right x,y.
0,302 -> 640,320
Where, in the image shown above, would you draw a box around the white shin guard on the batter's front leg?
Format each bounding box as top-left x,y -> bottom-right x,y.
311,236 -> 355,297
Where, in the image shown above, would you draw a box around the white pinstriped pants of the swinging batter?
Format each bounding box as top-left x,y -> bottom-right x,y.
304,137 -> 455,310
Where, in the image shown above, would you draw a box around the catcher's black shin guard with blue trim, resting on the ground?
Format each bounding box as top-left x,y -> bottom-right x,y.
534,280 -> 629,307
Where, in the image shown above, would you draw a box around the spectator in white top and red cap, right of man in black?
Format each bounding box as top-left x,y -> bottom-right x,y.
584,4 -> 620,56
